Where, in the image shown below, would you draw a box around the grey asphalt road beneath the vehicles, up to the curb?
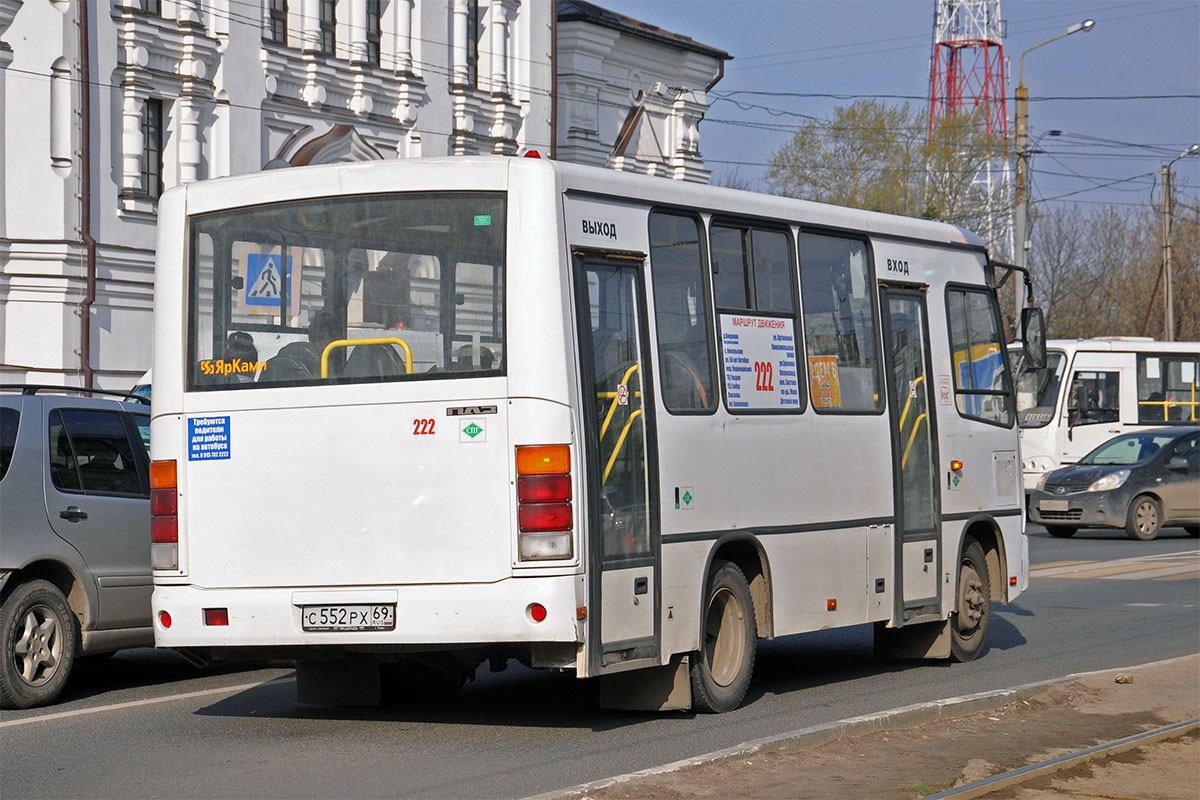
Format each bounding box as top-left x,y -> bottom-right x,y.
0,529 -> 1200,799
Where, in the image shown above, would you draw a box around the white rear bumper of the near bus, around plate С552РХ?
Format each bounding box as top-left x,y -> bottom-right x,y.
151,576 -> 584,651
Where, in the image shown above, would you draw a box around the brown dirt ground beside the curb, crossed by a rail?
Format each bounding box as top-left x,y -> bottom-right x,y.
564,655 -> 1200,800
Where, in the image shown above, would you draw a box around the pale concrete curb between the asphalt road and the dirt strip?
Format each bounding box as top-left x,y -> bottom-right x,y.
523,664 -> 1070,800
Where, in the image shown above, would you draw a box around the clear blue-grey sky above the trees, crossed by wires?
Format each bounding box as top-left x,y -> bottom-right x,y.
596,0 -> 1200,211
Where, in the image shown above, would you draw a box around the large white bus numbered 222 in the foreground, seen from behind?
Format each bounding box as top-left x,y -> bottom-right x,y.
151,157 -> 1028,711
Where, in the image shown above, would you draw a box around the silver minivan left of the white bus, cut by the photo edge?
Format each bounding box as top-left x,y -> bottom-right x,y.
0,386 -> 154,708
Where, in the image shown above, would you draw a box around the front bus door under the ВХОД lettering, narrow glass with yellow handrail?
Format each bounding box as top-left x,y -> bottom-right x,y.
881,287 -> 942,626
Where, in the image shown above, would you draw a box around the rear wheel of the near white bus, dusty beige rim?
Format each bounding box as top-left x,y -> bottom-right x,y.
690,560 -> 758,714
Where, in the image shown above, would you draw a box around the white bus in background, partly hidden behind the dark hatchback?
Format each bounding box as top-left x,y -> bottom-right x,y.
1016,337 -> 1200,492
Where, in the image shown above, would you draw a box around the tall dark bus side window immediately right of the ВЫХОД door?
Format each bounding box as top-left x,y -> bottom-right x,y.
650,211 -> 716,411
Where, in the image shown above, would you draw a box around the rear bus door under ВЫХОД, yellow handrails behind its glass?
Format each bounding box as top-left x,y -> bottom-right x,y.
575,251 -> 661,674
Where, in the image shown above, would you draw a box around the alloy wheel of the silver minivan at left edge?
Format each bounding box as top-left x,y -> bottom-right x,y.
0,581 -> 79,709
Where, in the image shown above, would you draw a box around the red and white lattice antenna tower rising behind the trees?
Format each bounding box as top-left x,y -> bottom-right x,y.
929,0 -> 1013,258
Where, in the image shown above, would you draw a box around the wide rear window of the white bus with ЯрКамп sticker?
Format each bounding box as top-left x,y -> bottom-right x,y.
187,192 -> 505,391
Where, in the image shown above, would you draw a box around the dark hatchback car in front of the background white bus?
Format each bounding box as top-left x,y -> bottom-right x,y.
1030,427 -> 1200,540
